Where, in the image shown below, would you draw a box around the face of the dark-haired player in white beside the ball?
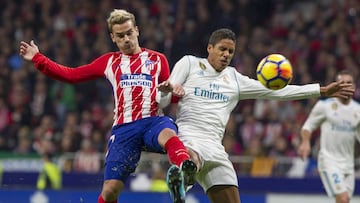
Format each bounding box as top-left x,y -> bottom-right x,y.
207,39 -> 235,72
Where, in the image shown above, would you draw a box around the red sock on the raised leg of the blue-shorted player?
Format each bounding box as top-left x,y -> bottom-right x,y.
165,136 -> 190,166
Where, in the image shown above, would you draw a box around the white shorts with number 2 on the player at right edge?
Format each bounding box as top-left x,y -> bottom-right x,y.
318,159 -> 355,197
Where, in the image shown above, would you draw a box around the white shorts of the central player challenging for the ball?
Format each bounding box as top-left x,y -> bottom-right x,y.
183,140 -> 238,192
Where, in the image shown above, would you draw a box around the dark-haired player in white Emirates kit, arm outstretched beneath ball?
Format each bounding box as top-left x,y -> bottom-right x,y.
158,29 -> 354,203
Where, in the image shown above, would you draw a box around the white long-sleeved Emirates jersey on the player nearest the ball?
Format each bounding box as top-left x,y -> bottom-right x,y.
170,56 -> 320,145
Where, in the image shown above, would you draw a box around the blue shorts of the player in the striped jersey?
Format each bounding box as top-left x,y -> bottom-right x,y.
104,116 -> 177,183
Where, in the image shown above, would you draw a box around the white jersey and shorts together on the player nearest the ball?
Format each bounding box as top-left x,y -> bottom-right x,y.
170,56 -> 320,192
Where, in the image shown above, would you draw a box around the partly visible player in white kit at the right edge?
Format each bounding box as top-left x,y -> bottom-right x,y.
298,71 -> 360,203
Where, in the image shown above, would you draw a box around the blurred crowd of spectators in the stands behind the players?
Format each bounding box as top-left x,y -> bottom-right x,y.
0,0 -> 360,172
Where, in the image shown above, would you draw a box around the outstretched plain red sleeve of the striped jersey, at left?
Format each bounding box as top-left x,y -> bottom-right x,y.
32,53 -> 109,83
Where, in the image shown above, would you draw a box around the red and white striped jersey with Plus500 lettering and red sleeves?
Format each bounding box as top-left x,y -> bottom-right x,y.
32,48 -> 170,125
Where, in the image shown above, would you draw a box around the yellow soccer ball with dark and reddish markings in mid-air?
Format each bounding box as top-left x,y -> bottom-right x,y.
256,54 -> 293,90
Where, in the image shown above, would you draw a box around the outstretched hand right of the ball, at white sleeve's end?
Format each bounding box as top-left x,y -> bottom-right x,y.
320,81 -> 355,99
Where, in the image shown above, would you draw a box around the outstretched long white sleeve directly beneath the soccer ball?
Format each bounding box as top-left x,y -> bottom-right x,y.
236,73 -> 320,101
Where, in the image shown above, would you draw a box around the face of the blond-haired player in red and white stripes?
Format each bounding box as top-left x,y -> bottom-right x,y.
110,20 -> 141,54
